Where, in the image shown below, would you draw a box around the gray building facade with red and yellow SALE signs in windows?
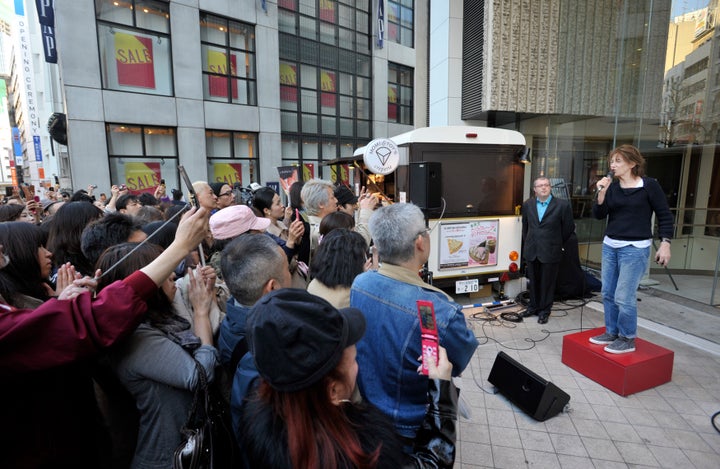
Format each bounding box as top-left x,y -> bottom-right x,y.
55,0 -> 428,191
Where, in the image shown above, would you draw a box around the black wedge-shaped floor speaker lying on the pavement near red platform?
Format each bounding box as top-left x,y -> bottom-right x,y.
488,352 -> 570,422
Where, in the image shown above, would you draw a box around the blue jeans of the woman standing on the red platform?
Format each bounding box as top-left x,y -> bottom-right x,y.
602,244 -> 650,339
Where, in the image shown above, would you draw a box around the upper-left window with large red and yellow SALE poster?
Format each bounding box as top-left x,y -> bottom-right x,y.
95,0 -> 173,96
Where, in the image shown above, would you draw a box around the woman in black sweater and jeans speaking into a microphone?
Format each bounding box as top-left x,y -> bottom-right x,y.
590,145 -> 673,353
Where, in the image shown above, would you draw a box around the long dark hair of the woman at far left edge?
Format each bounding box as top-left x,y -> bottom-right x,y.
0,221 -> 49,304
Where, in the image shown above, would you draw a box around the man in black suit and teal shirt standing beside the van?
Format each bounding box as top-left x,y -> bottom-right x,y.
522,176 -> 575,324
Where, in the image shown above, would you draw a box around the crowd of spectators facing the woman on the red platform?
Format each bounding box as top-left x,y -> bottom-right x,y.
0,179 -> 478,468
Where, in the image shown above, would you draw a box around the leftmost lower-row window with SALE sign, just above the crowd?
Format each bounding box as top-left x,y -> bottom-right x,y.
105,124 -> 179,194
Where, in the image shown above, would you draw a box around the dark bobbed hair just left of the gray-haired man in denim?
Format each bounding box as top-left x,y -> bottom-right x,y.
310,228 -> 367,288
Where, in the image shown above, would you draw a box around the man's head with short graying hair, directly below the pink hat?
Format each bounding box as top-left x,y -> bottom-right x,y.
220,233 -> 287,306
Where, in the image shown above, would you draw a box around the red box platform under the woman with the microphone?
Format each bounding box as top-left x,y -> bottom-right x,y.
562,327 -> 675,396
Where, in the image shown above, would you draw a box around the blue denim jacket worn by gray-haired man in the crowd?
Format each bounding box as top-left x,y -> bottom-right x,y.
350,263 -> 478,438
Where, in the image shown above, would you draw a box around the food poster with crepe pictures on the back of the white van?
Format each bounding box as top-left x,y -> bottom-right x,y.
439,220 -> 500,269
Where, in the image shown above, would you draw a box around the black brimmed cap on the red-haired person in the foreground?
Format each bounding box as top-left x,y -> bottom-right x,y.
247,288 -> 372,392
